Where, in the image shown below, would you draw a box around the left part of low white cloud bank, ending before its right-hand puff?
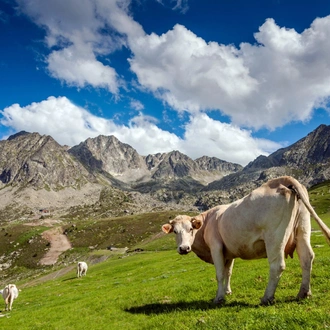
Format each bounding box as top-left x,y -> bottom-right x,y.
0,96 -> 179,154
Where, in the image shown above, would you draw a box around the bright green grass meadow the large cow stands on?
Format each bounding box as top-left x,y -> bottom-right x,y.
0,185 -> 330,330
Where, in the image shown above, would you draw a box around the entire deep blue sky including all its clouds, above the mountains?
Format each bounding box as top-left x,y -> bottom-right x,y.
0,0 -> 330,165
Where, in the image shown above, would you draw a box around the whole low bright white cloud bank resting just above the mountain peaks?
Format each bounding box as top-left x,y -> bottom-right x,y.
0,96 -> 279,165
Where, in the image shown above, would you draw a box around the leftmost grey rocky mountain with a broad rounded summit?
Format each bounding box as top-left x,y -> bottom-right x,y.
0,132 -> 95,190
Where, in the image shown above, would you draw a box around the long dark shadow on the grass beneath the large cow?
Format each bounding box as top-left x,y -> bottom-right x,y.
125,300 -> 258,315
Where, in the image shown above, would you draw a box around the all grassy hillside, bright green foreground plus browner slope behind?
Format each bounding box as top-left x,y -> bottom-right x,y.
0,182 -> 330,330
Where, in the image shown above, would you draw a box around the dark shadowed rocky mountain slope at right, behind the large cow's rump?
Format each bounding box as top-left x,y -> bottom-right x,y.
204,125 -> 330,191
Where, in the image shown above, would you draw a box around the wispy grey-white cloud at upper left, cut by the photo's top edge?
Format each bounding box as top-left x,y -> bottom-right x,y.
17,0 -> 143,94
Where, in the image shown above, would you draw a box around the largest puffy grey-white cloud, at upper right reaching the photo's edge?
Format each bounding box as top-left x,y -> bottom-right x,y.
128,16 -> 330,129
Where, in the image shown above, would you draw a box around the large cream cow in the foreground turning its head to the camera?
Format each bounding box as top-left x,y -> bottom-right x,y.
162,176 -> 330,305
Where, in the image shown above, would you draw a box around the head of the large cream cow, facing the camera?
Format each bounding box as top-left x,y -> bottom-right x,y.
162,215 -> 203,254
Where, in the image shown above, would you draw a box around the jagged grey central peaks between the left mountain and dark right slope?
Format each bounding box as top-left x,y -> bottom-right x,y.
68,135 -> 243,187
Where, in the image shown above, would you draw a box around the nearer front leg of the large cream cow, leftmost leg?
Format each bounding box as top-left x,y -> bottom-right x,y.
211,246 -> 230,304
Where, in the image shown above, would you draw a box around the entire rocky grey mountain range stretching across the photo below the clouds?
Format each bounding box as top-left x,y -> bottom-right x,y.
0,125 -> 330,220
